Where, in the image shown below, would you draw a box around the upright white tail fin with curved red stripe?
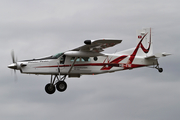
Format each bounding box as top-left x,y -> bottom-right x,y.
136,28 -> 153,57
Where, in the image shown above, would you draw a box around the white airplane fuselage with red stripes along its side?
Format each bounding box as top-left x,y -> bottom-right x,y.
18,54 -> 157,75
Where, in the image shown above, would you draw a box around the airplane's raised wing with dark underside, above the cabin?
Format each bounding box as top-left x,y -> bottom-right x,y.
71,39 -> 122,53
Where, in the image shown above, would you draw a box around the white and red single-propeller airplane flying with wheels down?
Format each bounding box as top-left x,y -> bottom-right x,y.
8,28 -> 170,94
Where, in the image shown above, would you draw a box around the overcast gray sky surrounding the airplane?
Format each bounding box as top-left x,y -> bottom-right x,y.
0,0 -> 180,120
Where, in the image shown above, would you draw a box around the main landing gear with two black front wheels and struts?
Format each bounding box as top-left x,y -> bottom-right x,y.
45,75 -> 67,94
